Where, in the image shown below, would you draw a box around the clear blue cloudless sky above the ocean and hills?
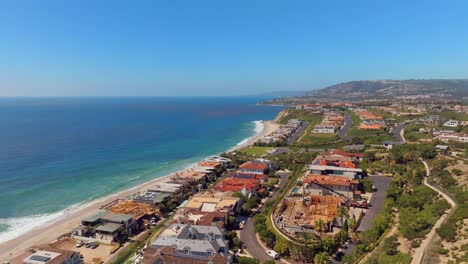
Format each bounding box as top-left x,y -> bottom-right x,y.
0,0 -> 468,96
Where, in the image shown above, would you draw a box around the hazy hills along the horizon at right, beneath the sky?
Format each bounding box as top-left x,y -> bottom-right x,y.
264,79 -> 468,104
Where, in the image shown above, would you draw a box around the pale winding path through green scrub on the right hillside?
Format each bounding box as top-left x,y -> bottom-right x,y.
411,160 -> 457,264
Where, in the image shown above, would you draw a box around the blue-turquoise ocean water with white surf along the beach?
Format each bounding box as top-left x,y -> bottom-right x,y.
0,97 -> 281,242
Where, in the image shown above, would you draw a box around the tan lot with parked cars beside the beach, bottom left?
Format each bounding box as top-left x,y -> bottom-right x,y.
56,238 -> 112,263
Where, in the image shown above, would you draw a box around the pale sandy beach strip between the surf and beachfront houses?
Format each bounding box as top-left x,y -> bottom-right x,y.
0,118 -> 279,261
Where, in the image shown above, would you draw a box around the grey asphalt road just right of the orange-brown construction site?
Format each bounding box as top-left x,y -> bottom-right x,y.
357,175 -> 392,232
